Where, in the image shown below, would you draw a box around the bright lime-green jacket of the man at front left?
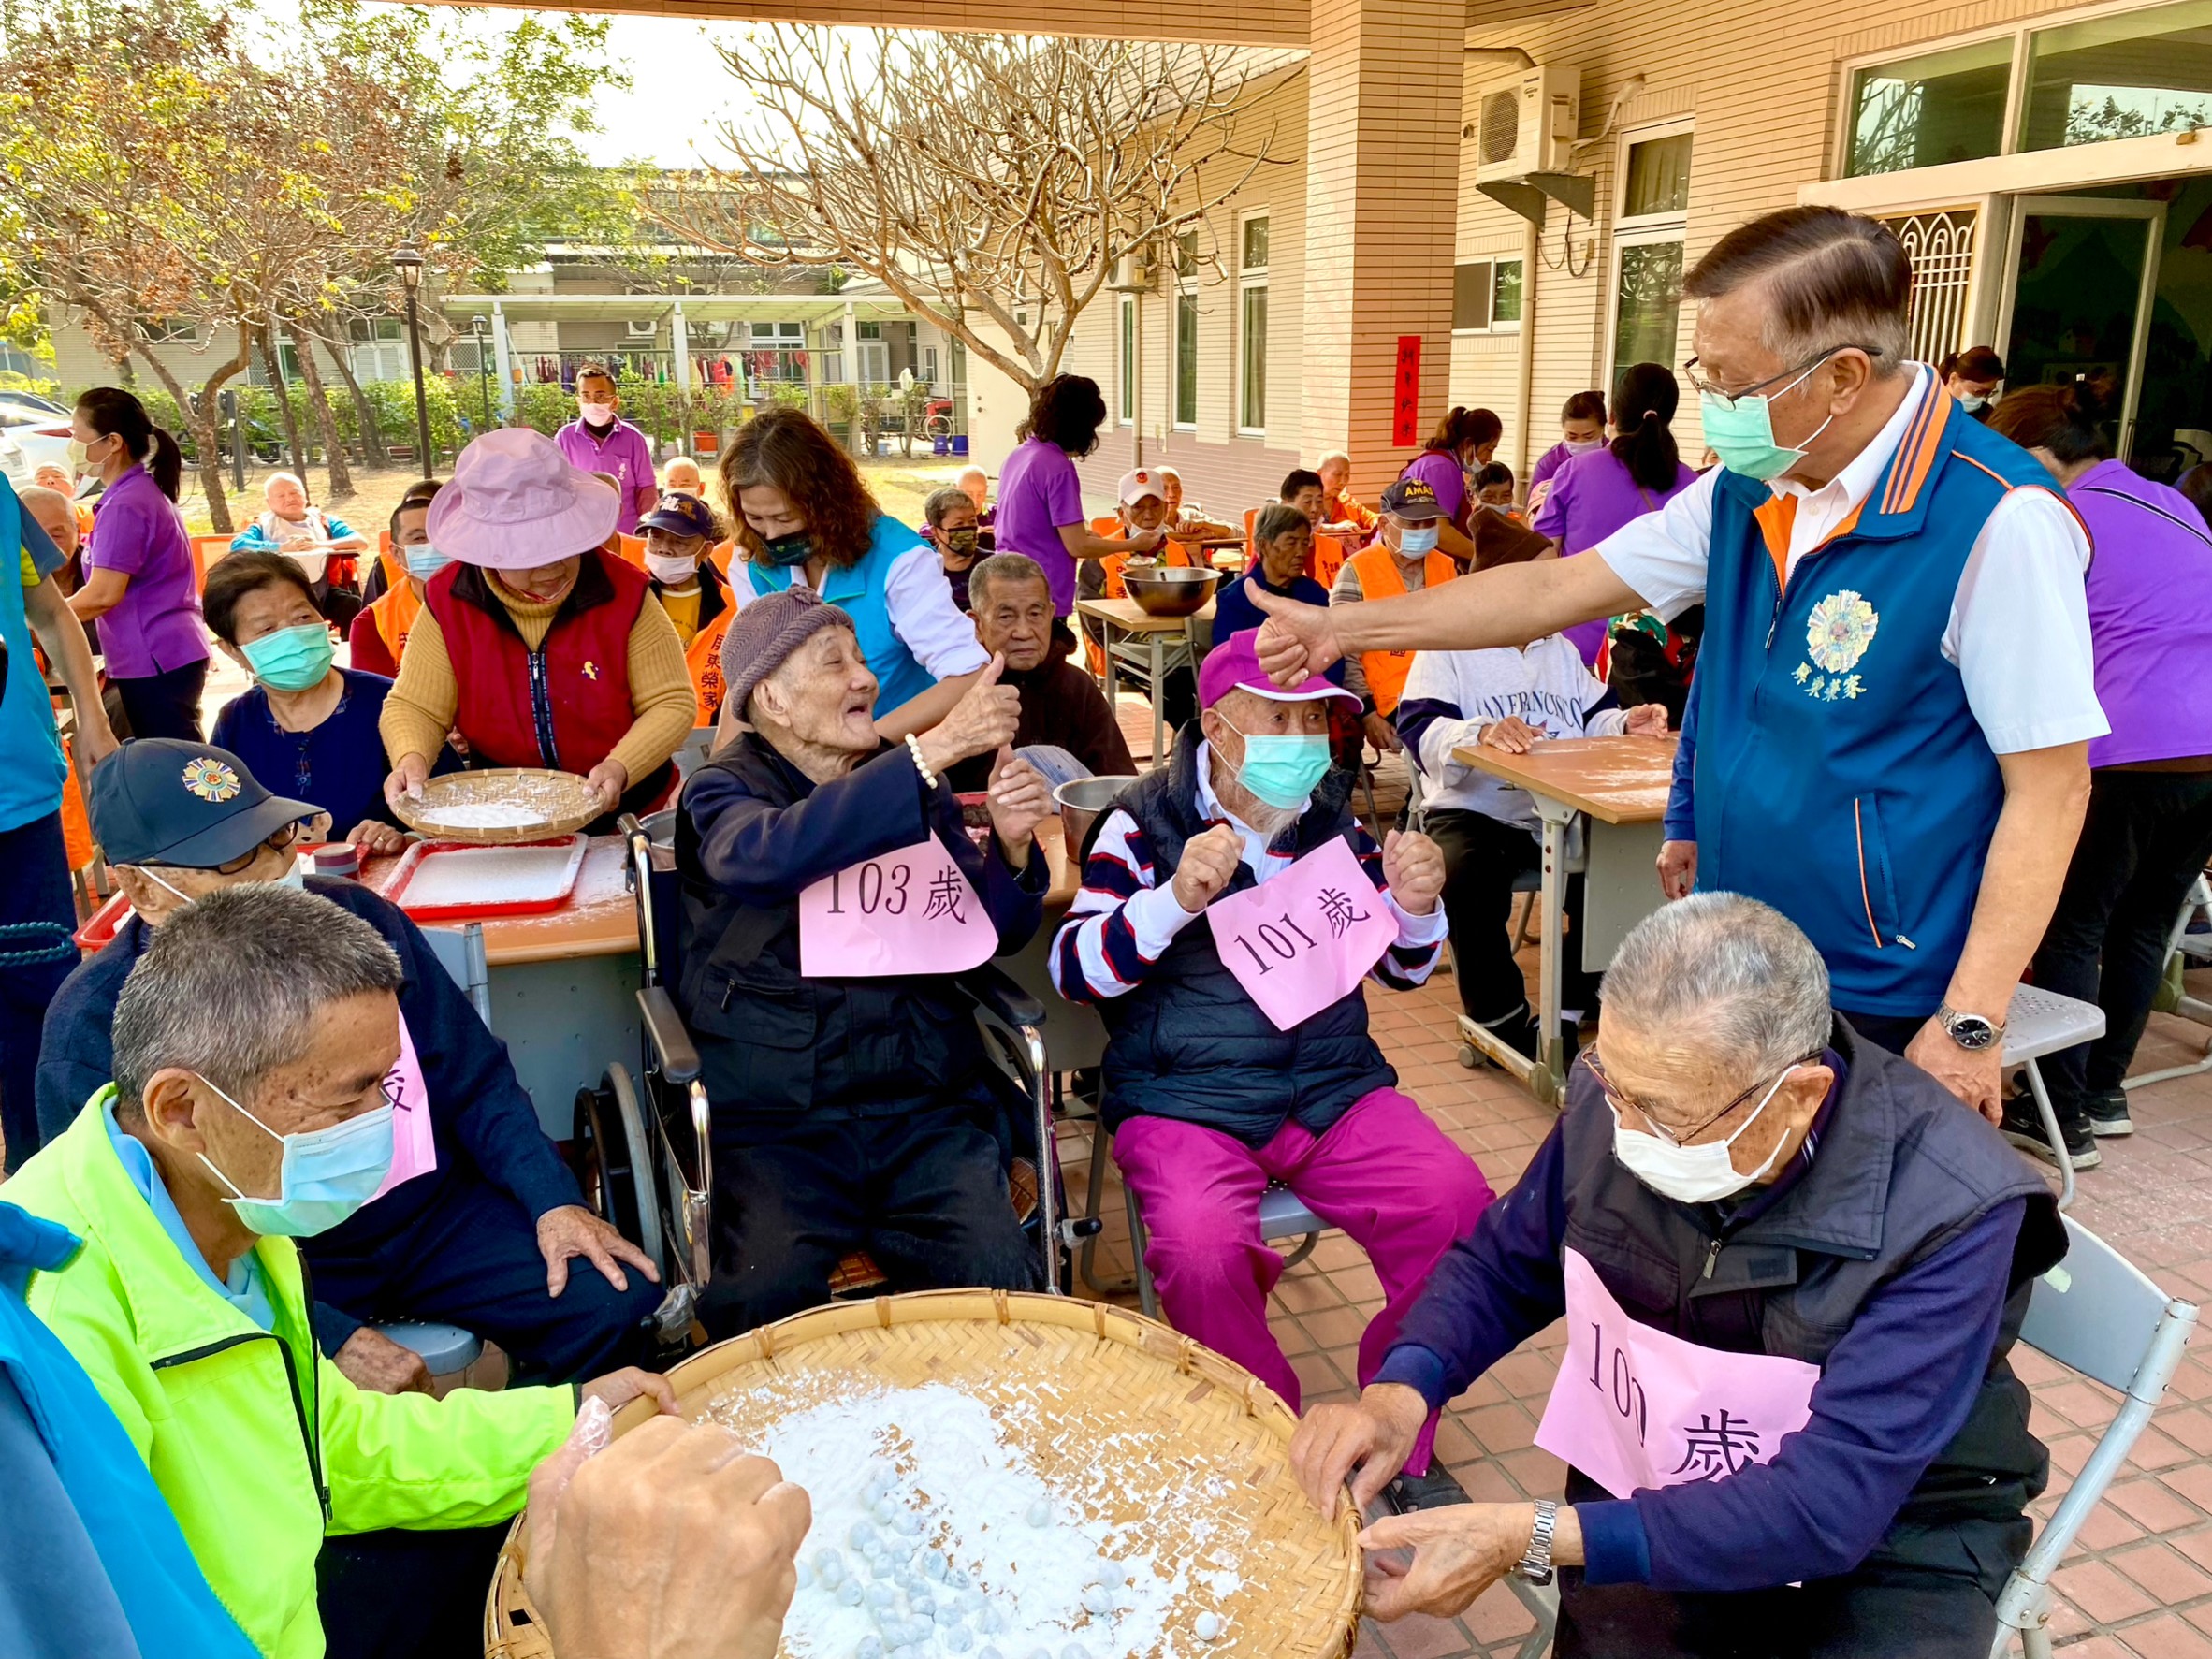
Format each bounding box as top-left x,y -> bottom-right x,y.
7,1090 -> 575,1659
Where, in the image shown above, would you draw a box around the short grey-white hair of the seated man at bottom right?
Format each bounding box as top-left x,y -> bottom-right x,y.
1604,894 -> 1834,1084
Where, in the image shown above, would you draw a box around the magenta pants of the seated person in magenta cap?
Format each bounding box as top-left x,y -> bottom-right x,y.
1113,1088 -> 1491,1473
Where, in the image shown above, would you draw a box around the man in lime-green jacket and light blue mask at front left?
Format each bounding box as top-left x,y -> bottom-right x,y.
7,882 -> 675,1659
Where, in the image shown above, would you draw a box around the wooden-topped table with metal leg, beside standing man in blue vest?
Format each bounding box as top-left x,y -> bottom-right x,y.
1451,736 -> 1675,1106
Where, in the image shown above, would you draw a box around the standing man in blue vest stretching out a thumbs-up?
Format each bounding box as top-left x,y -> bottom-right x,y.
1260,208 -> 2108,1122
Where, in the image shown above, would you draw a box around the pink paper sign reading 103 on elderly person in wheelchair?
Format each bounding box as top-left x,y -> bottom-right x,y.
798,837 -> 997,980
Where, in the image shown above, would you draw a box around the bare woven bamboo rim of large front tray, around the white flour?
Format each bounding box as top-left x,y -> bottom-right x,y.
485,1289 -> 1361,1659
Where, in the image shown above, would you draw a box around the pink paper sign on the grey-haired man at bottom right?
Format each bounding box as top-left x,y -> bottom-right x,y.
1535,1245 -> 1821,1497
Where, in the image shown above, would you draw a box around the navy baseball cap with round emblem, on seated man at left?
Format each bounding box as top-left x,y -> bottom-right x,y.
89,736 -> 321,869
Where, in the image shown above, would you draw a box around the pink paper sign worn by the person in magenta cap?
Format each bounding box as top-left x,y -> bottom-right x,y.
1205,837 -> 1398,1031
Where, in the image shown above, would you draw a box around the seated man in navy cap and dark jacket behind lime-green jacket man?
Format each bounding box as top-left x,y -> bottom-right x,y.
37,739 -> 663,1391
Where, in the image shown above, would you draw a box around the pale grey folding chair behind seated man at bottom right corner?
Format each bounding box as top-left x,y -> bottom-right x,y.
1988,1219 -> 2196,1659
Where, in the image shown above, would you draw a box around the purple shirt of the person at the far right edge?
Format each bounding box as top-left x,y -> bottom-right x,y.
2066,460 -> 2212,767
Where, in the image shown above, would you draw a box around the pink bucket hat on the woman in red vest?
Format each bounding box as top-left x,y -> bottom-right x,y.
423,427 -> 621,571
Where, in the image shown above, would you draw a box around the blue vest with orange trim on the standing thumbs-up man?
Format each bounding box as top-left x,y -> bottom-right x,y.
1695,387 -> 2055,1017
